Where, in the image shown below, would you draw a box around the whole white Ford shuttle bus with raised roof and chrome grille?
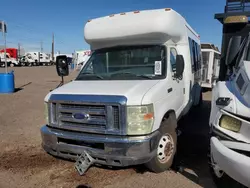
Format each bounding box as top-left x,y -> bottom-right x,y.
41,8 -> 202,174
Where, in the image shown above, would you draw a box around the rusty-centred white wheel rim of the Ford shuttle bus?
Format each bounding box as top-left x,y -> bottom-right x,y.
157,134 -> 174,163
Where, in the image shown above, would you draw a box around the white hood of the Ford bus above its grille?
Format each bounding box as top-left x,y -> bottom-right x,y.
45,80 -> 159,105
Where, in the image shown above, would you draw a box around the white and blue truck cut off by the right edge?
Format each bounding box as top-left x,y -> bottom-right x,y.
210,0 -> 250,187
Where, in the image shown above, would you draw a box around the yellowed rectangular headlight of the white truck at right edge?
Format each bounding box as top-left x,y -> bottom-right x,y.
220,115 -> 241,133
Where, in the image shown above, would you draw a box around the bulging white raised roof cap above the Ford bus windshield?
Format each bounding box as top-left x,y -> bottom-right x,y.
84,8 -> 199,50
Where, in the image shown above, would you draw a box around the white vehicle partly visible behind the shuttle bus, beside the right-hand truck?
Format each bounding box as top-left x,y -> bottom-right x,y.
201,43 -> 220,89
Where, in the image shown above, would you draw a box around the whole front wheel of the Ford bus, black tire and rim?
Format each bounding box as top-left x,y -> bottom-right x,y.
146,114 -> 177,173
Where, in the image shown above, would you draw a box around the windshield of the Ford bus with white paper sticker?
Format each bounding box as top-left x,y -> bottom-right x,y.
76,45 -> 166,80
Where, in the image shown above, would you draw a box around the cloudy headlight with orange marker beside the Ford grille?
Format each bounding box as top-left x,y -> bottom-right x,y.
127,104 -> 154,135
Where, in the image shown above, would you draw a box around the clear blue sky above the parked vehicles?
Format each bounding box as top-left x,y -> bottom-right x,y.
0,0 -> 226,53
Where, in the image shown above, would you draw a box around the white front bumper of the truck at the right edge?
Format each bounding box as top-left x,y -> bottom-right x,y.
211,137 -> 250,187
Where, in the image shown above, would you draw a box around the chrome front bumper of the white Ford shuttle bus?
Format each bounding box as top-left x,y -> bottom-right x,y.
41,126 -> 159,166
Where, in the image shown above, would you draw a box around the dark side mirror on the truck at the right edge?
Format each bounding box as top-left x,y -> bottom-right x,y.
226,36 -> 241,65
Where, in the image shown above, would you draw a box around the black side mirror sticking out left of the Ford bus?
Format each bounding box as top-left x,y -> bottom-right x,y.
56,55 -> 69,77
